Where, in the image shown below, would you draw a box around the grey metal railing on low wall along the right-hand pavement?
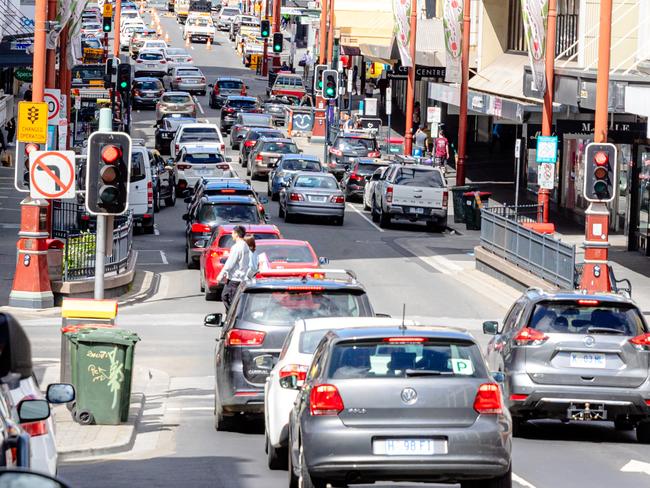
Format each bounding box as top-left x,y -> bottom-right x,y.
481,205 -> 576,289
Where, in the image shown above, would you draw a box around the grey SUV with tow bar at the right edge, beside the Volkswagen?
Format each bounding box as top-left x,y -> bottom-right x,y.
483,289 -> 650,443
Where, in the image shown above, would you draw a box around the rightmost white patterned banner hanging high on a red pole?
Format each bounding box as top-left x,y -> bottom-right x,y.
521,0 -> 548,93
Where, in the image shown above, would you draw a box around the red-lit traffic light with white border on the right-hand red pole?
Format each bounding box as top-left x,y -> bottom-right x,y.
584,142 -> 618,202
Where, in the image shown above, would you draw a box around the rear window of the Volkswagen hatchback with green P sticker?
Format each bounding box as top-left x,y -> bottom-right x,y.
328,337 -> 487,379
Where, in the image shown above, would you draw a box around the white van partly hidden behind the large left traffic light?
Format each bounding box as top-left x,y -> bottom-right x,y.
129,139 -> 154,234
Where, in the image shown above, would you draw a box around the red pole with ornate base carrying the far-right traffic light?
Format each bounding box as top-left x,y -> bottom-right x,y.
580,0 -> 618,292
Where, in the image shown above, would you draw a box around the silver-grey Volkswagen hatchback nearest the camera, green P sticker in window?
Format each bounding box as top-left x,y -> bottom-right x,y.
288,326 -> 512,488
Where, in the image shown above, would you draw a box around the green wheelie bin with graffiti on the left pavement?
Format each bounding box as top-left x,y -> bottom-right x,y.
68,328 -> 140,425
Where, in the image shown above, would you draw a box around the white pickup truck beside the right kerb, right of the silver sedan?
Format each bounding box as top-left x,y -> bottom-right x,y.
372,164 -> 449,231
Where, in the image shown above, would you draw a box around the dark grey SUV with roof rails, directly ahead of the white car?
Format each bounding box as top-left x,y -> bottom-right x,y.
205,269 -> 373,430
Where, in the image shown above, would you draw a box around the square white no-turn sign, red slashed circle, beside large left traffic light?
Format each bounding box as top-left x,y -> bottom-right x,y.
29,151 -> 76,199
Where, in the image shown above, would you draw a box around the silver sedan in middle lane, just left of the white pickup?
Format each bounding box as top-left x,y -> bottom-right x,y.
278,172 -> 345,225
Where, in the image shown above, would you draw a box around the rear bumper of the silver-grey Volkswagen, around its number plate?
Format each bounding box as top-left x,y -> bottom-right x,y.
301,416 -> 511,482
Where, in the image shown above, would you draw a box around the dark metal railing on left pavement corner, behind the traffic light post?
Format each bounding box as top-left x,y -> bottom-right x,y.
60,213 -> 133,281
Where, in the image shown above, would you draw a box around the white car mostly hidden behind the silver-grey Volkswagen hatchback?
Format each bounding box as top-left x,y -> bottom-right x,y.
264,317 -> 419,469
